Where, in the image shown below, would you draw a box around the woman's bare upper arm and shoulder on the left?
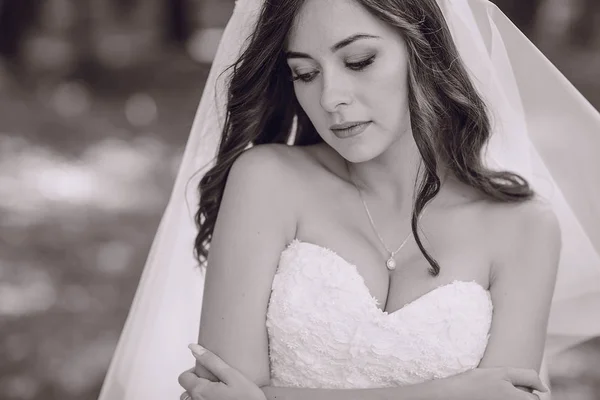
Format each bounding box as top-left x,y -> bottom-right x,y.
196,145 -> 296,386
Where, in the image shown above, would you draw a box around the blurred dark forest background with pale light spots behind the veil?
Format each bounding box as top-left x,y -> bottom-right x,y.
0,0 -> 600,400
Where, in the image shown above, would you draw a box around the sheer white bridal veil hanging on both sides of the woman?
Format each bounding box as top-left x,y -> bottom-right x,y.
100,0 -> 600,400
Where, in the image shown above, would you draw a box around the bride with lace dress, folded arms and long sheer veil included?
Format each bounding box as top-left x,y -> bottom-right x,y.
96,0 -> 600,399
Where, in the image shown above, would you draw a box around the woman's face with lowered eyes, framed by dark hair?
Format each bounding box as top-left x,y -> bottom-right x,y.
287,0 -> 410,162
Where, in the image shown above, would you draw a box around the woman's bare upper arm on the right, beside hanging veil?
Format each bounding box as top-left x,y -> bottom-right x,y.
479,201 -> 561,372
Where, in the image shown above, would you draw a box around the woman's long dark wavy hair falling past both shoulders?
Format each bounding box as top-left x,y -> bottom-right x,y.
195,0 -> 534,276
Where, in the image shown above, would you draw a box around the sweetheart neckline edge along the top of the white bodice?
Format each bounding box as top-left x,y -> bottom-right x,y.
282,238 -> 489,316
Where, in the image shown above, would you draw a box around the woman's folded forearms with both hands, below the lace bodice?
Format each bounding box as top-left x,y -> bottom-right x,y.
179,345 -> 548,400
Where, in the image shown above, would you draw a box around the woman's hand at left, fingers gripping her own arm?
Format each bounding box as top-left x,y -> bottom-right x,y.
179,344 -> 266,400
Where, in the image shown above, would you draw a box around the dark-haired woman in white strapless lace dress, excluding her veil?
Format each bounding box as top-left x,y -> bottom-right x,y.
96,0 -> 600,398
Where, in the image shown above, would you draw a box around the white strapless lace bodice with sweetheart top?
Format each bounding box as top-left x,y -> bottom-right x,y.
267,240 -> 492,389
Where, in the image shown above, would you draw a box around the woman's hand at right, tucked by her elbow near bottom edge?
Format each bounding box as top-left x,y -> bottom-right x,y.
439,368 -> 548,400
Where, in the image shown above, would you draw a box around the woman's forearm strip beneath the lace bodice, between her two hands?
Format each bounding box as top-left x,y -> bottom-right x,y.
261,380 -> 450,400
